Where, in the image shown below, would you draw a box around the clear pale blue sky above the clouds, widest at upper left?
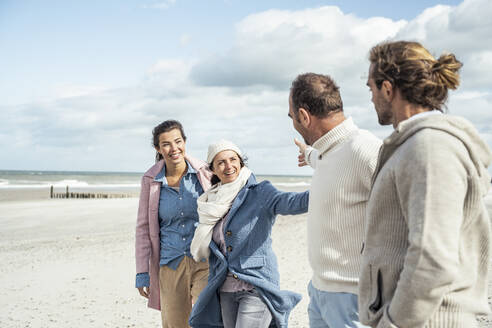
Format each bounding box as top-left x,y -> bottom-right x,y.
0,0 -> 459,104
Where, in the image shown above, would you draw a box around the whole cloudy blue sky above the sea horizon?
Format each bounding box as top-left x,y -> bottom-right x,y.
0,0 -> 492,175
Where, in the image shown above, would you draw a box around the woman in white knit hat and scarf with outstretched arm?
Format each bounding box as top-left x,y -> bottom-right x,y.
190,140 -> 309,328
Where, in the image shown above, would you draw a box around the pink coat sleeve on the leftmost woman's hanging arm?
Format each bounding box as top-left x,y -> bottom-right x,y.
135,177 -> 151,274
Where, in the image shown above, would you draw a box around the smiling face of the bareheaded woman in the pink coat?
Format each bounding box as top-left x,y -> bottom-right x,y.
155,129 -> 186,166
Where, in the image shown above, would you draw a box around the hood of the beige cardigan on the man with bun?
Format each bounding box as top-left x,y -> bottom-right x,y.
380,114 -> 492,194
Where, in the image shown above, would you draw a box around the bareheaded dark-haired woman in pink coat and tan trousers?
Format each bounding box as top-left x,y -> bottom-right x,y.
135,120 -> 212,328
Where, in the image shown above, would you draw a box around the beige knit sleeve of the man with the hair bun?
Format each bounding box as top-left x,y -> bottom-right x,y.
384,130 -> 469,327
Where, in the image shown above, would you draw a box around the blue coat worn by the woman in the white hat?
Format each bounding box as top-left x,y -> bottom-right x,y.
189,175 -> 309,328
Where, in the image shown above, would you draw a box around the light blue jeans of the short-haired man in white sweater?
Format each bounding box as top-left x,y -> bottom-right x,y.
308,281 -> 366,328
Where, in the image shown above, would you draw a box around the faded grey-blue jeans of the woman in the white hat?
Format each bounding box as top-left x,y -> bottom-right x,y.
220,289 -> 272,328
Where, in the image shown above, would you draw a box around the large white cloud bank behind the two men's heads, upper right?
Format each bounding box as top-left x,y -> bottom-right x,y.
191,0 -> 492,153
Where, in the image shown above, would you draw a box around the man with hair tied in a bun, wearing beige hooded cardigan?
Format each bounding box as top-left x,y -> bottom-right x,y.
359,41 -> 492,328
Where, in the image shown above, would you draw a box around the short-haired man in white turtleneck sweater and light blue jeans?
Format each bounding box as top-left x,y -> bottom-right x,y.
289,73 -> 381,328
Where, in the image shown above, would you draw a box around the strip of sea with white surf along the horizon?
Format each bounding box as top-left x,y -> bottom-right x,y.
0,170 -> 311,200
